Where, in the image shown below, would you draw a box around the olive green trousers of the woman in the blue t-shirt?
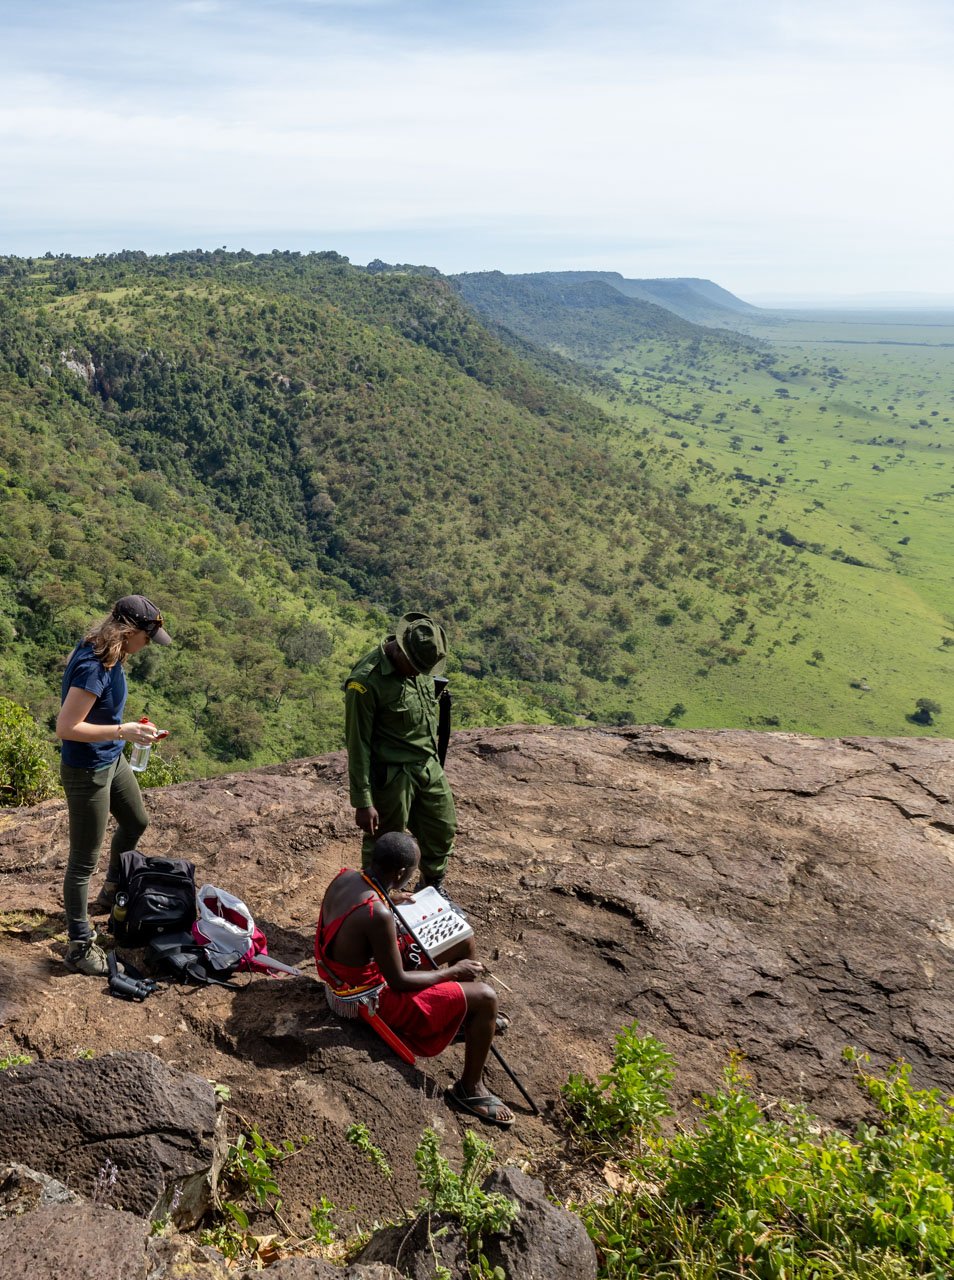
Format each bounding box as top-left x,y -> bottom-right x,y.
60,755 -> 149,941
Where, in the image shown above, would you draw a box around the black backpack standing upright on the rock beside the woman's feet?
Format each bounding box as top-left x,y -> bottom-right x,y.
113,849 -> 196,947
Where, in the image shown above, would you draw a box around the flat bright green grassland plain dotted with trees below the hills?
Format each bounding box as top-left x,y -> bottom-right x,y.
594,305 -> 954,733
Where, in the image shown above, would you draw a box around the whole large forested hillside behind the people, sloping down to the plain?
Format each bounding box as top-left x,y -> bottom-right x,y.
0,251 -> 812,767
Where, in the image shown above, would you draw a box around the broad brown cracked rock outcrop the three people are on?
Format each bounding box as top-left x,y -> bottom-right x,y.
0,727 -> 954,1216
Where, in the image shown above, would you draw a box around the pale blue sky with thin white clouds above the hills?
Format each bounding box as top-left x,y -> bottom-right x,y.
0,0 -> 954,305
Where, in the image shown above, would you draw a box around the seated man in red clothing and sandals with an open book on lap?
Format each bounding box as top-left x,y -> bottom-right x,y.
315,831 -> 513,1129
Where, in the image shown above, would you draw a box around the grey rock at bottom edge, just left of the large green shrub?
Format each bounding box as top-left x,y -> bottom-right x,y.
483,1169 -> 597,1280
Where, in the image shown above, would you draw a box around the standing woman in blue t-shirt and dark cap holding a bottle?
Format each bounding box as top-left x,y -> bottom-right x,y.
56,595 -> 170,975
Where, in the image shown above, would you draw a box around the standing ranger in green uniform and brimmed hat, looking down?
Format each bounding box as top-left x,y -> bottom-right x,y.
344,613 -> 457,888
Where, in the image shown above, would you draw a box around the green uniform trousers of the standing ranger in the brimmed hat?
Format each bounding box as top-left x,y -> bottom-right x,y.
361,759 -> 457,881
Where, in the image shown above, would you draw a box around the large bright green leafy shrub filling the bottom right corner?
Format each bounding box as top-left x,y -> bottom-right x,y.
565,1028 -> 954,1280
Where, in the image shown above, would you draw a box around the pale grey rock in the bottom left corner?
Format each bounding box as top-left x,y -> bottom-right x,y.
0,1204 -> 149,1280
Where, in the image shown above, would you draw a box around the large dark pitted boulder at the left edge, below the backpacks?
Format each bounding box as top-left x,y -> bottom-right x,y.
0,1053 -> 225,1228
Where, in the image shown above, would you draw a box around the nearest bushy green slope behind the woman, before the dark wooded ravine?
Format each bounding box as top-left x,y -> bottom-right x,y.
0,264 -> 542,772
